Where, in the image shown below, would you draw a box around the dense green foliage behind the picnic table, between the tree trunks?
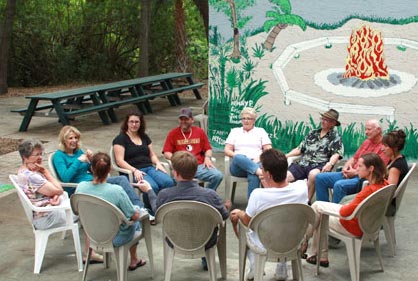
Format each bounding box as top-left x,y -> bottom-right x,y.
6,0 -> 208,86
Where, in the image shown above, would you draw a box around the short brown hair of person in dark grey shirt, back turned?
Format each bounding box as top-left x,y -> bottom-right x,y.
171,150 -> 198,180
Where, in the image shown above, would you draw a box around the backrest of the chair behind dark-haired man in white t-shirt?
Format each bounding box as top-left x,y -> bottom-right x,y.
248,203 -> 315,255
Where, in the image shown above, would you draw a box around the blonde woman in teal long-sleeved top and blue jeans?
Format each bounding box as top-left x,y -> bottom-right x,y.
52,126 -> 143,207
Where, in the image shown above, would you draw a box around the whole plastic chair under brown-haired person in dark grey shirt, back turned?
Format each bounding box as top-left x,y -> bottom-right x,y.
155,200 -> 226,281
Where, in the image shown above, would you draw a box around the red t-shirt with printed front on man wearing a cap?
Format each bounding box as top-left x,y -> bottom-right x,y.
163,126 -> 212,165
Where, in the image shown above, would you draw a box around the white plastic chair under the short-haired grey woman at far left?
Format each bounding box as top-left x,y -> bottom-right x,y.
9,175 -> 83,274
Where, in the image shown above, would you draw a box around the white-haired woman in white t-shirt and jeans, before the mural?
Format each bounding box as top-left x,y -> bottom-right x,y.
224,107 -> 272,198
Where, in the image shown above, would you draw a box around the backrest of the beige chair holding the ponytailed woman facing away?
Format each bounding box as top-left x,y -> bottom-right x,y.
70,193 -> 126,247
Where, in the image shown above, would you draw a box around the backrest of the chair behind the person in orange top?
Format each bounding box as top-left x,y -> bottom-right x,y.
353,184 -> 396,236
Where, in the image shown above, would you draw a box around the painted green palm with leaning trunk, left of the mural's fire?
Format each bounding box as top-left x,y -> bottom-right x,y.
263,0 -> 306,51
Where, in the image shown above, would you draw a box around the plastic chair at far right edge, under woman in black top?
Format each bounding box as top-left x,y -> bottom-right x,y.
383,163 -> 416,256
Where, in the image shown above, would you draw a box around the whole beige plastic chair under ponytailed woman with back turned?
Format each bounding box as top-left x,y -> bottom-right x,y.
71,193 -> 154,281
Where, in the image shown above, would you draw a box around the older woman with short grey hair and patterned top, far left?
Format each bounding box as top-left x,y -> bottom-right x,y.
17,140 -> 66,229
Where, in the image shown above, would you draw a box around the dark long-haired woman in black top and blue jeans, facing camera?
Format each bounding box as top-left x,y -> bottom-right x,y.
113,113 -> 175,203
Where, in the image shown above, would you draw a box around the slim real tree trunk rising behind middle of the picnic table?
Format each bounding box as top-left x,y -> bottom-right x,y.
138,0 -> 151,77
